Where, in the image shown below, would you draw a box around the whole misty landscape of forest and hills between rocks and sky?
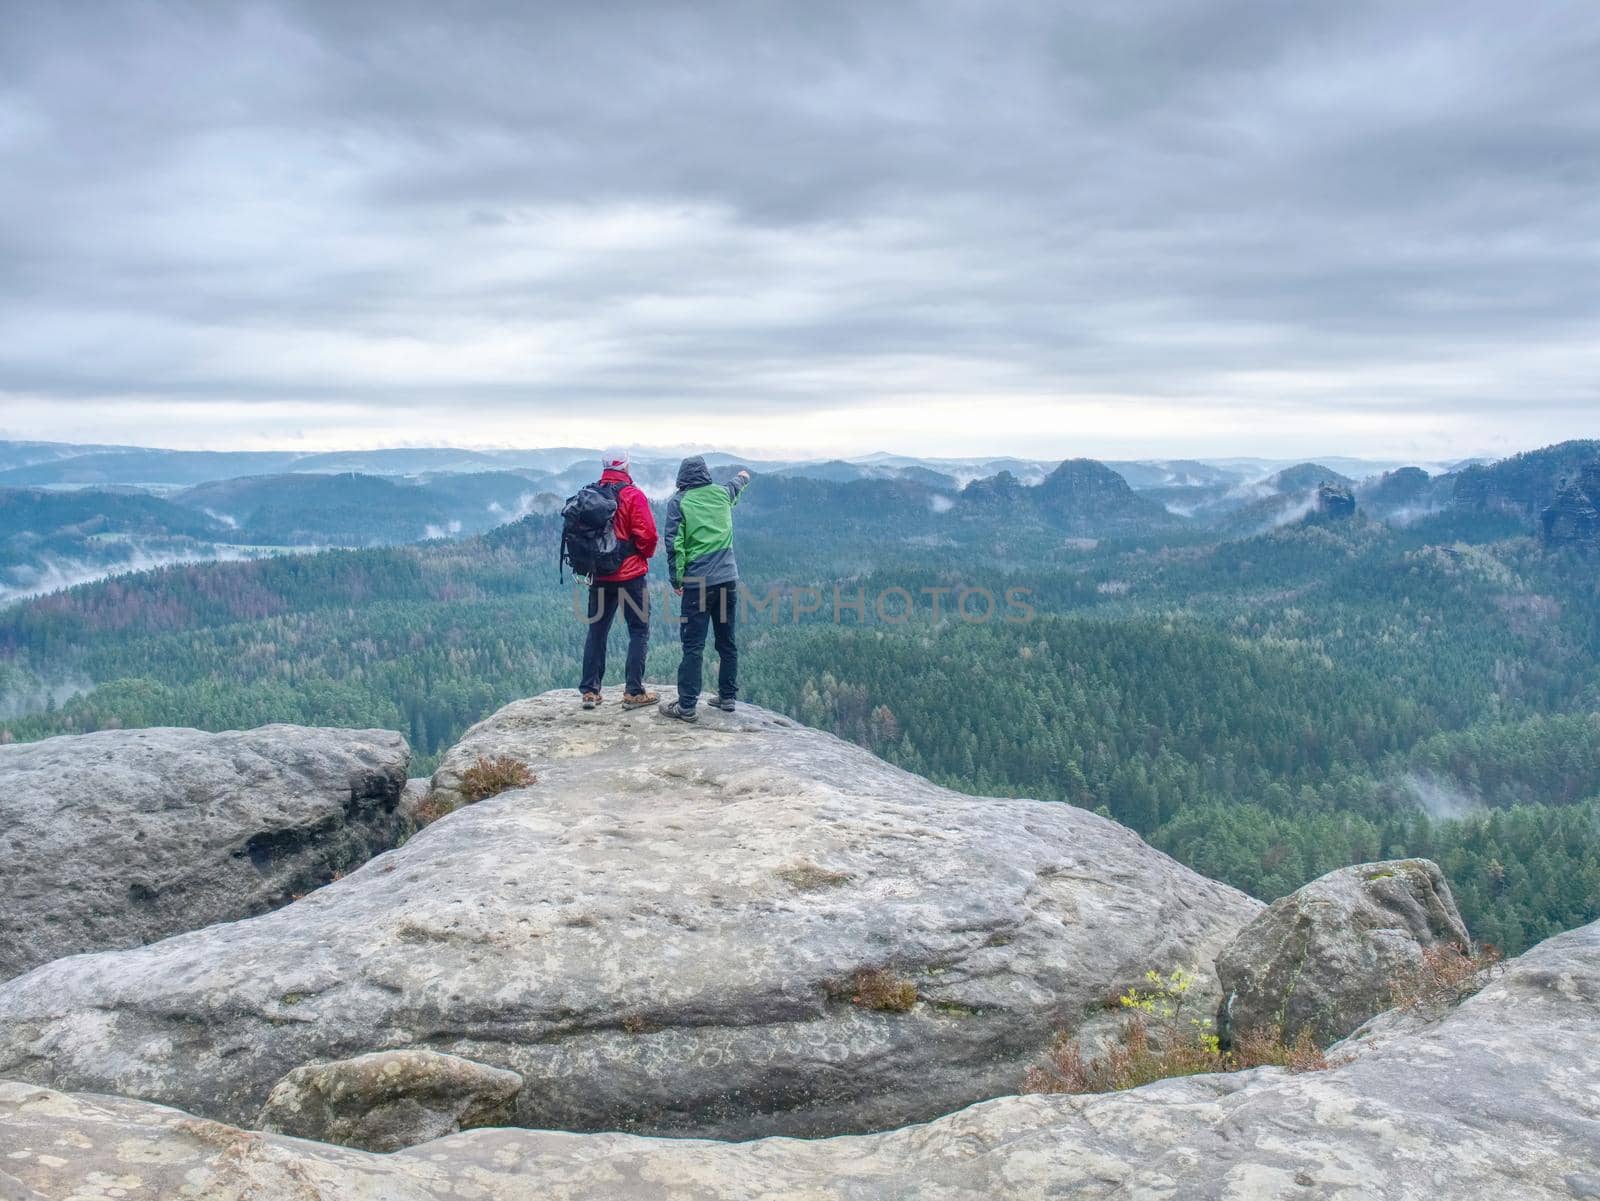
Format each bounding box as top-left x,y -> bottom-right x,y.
0,443 -> 1600,953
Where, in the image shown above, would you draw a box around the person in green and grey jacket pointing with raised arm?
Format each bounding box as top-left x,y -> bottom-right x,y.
661,454 -> 750,721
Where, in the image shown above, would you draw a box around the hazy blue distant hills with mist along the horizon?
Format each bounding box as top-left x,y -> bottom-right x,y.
0,441 -> 1600,603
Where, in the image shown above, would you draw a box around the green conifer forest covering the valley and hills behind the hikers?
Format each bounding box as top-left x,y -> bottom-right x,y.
0,447 -> 1600,952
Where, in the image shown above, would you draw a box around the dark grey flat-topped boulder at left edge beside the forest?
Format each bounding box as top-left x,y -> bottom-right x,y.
0,726 -> 411,979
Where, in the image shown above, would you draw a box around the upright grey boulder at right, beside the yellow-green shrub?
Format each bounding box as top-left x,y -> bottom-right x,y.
1216,859 -> 1470,1046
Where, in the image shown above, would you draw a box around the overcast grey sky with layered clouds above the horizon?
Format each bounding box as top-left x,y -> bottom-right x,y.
0,0 -> 1600,459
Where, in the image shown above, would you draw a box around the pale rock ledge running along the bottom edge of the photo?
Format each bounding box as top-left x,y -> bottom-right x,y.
0,924 -> 1600,1201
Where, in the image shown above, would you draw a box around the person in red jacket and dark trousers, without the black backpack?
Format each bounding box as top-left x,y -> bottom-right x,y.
578,451 -> 656,708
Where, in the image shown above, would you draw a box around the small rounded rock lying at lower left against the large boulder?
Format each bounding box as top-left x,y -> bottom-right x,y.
256,1051 -> 522,1151
